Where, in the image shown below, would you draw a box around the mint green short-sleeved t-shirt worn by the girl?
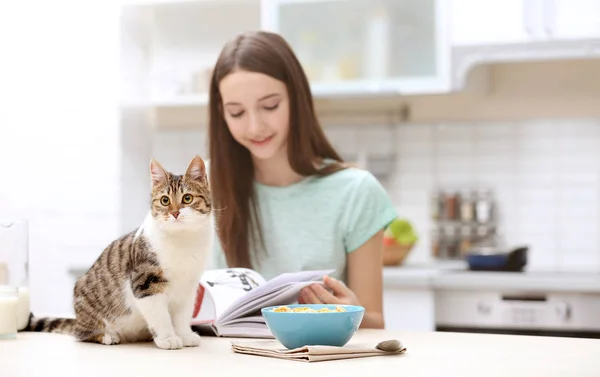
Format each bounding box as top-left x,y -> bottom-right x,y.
212,164 -> 397,281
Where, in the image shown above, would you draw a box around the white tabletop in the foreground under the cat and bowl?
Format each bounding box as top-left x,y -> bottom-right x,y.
0,330 -> 600,377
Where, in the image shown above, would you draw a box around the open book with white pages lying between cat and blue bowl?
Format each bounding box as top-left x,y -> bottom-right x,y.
191,268 -> 334,338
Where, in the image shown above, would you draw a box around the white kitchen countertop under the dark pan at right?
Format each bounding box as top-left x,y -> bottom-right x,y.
384,262 -> 600,293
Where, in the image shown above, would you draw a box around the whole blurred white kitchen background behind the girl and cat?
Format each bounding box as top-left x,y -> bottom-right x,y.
0,0 -> 600,333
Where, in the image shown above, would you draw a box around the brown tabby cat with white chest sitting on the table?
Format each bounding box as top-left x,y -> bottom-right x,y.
25,156 -> 213,349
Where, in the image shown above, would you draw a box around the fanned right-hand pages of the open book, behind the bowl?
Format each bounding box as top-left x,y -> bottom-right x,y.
217,270 -> 334,324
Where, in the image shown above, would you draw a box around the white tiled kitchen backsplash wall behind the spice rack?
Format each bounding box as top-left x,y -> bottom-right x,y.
150,119 -> 600,272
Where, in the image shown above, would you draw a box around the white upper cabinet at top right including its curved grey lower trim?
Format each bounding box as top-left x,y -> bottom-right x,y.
449,0 -> 600,90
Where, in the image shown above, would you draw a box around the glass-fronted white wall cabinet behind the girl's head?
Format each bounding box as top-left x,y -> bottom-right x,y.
262,0 -> 450,96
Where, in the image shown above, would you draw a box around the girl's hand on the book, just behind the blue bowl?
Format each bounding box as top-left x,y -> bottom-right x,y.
298,276 -> 360,305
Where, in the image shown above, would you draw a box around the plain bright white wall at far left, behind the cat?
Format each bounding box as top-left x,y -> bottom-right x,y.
0,1 -> 121,314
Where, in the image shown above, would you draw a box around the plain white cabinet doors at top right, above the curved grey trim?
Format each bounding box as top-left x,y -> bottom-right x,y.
451,0 -> 600,46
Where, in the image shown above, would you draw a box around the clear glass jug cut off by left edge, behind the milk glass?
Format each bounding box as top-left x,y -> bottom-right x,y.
0,220 -> 30,330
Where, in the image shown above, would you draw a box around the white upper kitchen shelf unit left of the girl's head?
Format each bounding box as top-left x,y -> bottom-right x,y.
121,0 -> 260,108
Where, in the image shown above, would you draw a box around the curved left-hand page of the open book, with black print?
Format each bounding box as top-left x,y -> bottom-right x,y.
192,268 -> 266,324
